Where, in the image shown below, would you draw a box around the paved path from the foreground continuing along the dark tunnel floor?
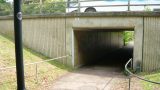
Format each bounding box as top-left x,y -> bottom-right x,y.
50,42 -> 143,90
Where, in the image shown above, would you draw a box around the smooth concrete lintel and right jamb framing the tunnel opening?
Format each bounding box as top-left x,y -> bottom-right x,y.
70,16 -> 143,69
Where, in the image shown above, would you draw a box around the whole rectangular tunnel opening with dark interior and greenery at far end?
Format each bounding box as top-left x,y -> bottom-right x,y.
74,29 -> 134,68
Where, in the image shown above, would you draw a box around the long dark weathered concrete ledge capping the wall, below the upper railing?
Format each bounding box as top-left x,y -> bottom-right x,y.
0,11 -> 160,19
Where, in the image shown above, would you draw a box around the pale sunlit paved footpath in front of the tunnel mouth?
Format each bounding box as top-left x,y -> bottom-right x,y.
50,66 -> 143,90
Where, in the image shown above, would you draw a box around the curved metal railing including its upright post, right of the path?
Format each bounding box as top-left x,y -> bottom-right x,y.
125,58 -> 160,90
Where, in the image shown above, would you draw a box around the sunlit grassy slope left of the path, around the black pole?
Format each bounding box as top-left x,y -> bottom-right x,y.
0,35 -> 71,90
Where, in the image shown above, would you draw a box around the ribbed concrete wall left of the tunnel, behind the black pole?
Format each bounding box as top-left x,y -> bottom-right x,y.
0,17 -> 67,64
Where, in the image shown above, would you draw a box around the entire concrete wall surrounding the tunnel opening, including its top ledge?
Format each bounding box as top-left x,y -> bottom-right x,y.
0,12 -> 160,71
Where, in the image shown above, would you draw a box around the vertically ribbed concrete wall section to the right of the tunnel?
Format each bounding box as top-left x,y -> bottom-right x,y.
143,17 -> 160,71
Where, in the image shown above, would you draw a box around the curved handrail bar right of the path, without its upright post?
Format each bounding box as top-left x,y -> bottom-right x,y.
125,58 -> 160,84
